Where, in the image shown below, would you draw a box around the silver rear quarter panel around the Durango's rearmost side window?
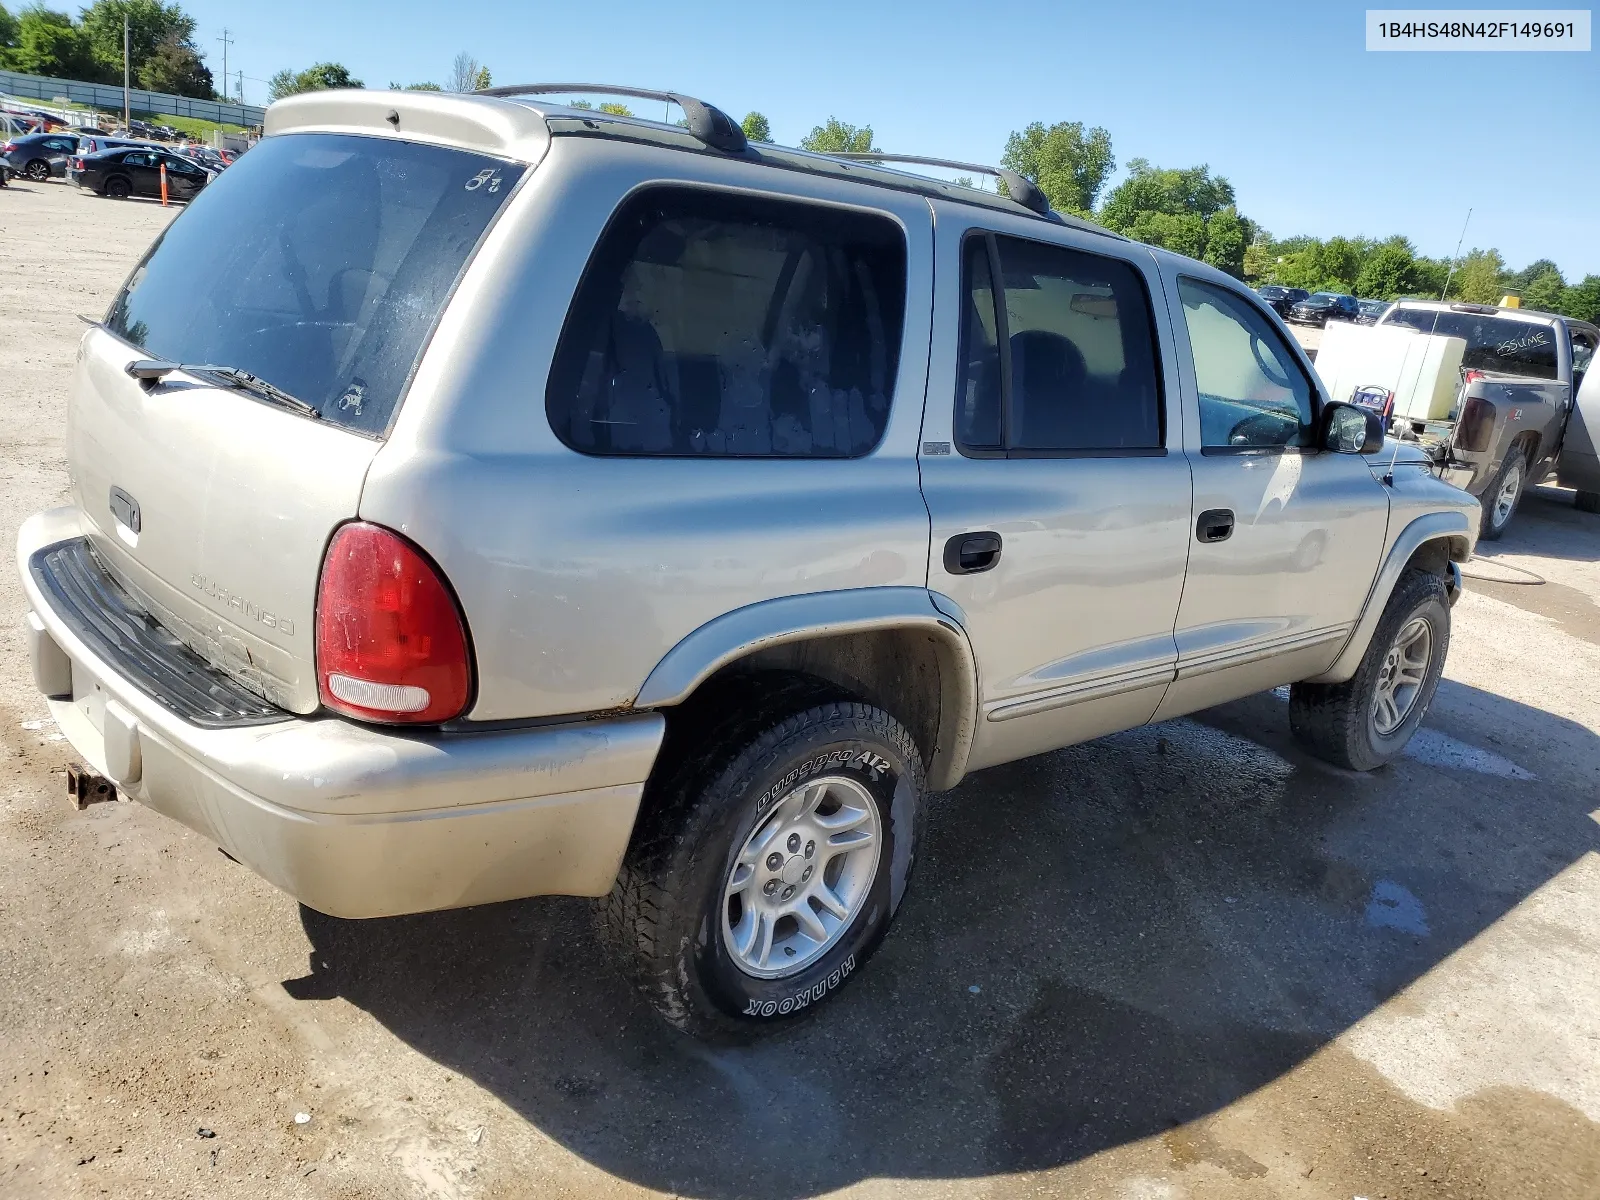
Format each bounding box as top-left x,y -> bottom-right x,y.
362,138 -> 933,720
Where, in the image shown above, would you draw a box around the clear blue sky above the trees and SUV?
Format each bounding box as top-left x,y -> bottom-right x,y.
181,0 -> 1600,280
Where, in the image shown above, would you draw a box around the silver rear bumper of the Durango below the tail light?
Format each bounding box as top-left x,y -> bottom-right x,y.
18,509 -> 666,917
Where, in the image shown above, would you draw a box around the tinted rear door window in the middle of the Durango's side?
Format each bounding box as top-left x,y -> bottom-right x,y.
955,235 -> 1163,458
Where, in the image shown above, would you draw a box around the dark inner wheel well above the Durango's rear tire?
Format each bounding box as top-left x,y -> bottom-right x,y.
662,629 -> 976,790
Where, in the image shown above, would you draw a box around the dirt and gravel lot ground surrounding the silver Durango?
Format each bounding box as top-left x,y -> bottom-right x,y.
0,184 -> 1600,1200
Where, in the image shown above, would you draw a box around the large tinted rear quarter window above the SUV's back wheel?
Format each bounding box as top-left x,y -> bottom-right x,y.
546,187 -> 906,458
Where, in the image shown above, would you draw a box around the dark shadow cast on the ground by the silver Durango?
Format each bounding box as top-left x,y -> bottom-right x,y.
285,682 -> 1600,1198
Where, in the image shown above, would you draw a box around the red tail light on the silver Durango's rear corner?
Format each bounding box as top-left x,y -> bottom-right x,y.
317,522 -> 472,725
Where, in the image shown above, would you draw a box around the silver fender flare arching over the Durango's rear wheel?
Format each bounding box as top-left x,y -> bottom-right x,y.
634,587 -> 978,790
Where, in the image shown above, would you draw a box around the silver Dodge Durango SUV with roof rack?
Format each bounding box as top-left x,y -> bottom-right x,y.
18,88 -> 1477,1035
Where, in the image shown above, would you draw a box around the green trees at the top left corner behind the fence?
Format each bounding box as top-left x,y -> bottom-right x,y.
0,0 -> 214,99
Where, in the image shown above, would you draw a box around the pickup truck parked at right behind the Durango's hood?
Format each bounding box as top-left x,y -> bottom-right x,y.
1378,301 -> 1600,539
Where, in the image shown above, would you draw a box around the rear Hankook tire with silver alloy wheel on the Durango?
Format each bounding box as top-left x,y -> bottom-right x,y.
598,677 -> 925,1040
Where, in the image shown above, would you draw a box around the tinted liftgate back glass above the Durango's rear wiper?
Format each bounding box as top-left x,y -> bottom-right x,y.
106,133 -> 523,434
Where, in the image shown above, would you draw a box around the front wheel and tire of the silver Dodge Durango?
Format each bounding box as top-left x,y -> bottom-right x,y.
1290,571 -> 1450,771
